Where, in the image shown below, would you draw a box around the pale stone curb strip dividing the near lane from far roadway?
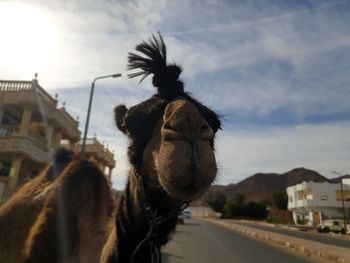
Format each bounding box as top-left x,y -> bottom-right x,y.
205,219 -> 350,263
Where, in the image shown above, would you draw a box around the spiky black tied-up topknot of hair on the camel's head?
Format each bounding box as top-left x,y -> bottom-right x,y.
127,33 -> 184,101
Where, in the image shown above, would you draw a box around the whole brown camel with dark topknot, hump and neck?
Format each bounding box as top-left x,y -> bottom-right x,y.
0,35 -> 220,263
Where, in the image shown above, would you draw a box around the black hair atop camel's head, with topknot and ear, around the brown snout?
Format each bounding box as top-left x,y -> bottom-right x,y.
114,33 -> 221,138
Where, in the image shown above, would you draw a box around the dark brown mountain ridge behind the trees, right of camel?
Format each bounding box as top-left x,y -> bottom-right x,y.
191,168 -> 333,205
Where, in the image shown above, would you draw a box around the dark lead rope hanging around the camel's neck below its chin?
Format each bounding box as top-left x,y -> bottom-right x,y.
130,173 -> 188,263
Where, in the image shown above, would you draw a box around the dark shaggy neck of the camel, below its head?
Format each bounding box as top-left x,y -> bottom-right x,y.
115,171 -> 178,263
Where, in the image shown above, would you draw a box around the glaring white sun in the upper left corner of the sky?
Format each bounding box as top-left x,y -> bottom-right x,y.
0,2 -> 59,76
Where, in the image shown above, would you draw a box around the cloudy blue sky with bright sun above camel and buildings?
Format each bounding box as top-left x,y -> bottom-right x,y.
0,0 -> 350,189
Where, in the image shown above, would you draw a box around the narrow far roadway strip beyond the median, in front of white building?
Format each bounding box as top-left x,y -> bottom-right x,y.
233,220 -> 350,251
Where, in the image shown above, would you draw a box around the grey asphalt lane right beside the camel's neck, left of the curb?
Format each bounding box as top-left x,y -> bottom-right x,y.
162,220 -> 311,263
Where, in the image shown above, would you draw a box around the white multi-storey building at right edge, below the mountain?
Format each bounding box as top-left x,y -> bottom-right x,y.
287,182 -> 350,226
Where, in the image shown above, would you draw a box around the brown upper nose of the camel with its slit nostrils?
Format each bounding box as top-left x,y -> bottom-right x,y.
161,99 -> 214,142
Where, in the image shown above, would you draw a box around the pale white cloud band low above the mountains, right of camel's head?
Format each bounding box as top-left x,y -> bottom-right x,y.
216,122 -> 350,186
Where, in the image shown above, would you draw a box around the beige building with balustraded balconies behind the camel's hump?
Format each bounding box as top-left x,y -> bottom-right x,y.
0,79 -> 115,202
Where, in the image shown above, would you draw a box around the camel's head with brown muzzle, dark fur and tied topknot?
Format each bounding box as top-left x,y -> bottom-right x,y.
115,35 -> 220,202
